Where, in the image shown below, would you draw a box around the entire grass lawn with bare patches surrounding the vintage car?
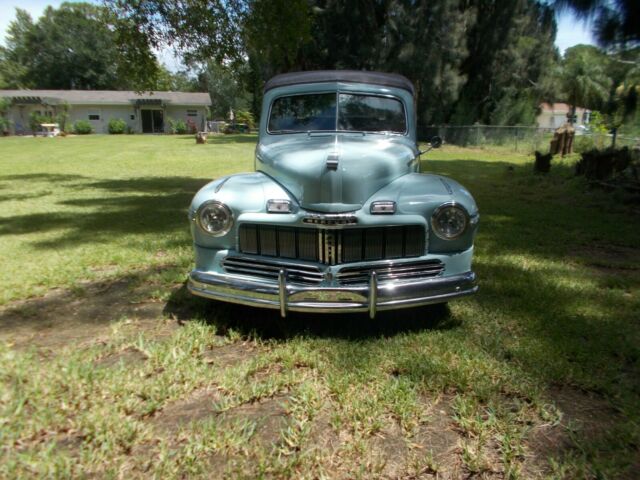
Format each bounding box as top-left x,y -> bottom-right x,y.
0,136 -> 640,479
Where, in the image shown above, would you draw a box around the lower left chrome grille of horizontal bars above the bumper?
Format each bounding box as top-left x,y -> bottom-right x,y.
222,256 -> 323,285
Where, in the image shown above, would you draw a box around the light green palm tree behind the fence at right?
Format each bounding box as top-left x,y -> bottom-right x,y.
561,45 -> 612,123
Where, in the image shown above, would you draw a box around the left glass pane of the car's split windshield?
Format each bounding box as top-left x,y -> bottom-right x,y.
269,93 -> 336,133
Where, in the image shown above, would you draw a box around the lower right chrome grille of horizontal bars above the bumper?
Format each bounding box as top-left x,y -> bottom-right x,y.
336,260 -> 444,285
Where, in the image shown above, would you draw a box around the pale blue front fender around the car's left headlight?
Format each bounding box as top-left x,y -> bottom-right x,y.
189,172 -> 295,248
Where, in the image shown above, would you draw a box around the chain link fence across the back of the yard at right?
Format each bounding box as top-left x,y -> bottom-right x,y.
420,125 -> 640,153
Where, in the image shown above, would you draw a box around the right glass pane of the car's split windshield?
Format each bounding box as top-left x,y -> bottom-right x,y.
338,93 -> 407,133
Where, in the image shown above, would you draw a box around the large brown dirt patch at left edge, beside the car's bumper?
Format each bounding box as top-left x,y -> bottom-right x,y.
0,270 -> 178,349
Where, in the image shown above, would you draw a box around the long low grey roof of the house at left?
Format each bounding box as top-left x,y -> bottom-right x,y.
0,90 -> 211,106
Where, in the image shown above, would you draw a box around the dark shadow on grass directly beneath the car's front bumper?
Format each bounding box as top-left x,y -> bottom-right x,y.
164,283 -> 457,340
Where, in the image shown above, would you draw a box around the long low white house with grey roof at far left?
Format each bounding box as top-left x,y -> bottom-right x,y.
0,90 -> 211,135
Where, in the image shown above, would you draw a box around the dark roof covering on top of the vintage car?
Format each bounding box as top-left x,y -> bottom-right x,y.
264,70 -> 413,95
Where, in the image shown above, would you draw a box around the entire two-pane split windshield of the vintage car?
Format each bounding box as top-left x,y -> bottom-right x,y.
268,93 -> 407,134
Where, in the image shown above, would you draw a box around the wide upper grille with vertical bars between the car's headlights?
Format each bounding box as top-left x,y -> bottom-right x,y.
238,224 -> 425,265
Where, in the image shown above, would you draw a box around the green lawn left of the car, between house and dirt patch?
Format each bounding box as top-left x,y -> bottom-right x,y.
0,136 -> 254,304
